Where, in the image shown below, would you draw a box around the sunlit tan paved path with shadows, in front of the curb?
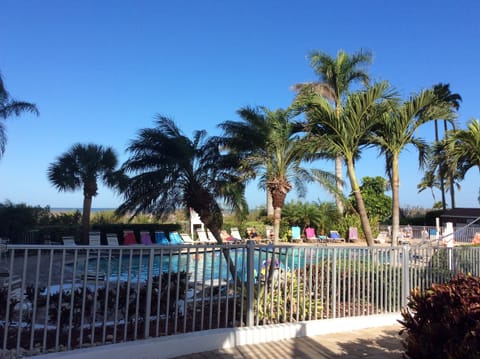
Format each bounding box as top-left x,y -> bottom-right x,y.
172,325 -> 404,359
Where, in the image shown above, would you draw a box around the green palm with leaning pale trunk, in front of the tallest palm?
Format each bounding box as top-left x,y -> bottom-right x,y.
296,82 -> 392,246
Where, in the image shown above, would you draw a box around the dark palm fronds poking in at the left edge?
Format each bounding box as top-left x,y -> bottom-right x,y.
0,74 -> 38,158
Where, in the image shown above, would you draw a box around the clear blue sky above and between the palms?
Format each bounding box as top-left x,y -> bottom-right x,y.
0,0 -> 480,211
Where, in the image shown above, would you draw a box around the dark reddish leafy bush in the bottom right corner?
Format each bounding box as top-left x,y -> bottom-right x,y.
400,274 -> 480,358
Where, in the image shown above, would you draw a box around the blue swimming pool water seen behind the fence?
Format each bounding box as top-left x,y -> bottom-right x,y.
72,247 -> 386,282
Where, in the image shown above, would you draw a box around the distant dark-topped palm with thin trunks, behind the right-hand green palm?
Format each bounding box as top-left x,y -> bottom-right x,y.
433,83 -> 462,210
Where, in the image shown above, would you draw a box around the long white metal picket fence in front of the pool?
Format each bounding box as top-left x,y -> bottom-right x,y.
0,241 -> 480,357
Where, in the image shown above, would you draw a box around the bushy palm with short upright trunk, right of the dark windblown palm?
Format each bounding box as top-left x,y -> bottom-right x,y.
219,107 -> 318,242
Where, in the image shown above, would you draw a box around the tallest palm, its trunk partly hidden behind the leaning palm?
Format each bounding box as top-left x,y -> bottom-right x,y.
293,50 -> 372,213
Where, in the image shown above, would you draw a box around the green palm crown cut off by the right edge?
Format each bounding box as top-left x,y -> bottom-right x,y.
446,119 -> 480,193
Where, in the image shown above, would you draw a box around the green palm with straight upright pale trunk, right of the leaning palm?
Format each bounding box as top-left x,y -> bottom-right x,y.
371,90 -> 453,245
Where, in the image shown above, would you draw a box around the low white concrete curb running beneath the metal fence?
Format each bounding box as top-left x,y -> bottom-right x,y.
36,313 -> 401,359
